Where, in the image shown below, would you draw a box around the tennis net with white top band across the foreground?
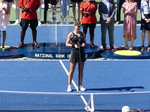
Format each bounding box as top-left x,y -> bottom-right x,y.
0,91 -> 150,112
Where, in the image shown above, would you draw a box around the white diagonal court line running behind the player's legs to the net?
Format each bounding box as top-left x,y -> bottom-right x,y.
59,60 -> 93,109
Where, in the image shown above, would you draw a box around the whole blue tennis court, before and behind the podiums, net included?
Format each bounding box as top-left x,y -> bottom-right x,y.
0,4 -> 150,112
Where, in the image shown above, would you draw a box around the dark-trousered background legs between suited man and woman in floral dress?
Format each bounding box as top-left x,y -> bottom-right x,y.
115,0 -> 125,24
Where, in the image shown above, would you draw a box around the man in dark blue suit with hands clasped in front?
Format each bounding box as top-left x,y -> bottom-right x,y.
99,0 -> 116,51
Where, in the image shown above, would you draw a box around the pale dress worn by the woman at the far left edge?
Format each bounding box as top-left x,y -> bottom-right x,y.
0,2 -> 9,31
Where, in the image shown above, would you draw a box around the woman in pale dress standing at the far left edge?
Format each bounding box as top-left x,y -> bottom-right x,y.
0,0 -> 10,50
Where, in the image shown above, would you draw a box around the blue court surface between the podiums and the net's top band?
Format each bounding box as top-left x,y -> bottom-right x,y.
0,60 -> 150,93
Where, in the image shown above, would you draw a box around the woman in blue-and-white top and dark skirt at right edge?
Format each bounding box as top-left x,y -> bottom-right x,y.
141,0 -> 150,51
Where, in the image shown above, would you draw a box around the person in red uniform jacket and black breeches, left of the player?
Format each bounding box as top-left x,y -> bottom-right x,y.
18,0 -> 40,48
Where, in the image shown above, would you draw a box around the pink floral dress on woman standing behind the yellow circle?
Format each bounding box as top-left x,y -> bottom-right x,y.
123,2 -> 138,41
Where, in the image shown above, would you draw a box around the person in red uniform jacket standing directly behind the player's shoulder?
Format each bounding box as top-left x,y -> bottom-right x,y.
80,0 -> 97,48
